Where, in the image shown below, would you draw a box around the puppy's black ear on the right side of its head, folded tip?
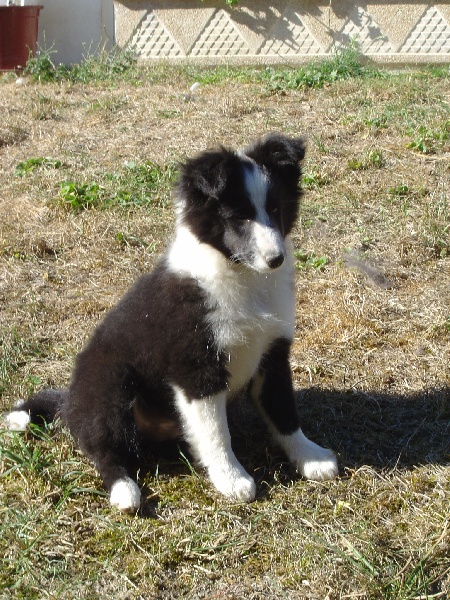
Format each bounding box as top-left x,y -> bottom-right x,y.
245,133 -> 306,171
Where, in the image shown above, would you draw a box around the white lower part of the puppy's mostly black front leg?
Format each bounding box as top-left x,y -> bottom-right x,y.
275,429 -> 338,481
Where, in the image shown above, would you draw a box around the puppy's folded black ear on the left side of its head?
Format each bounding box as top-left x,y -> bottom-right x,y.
178,148 -> 238,203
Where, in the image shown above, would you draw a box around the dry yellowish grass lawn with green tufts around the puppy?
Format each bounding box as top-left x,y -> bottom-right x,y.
0,51 -> 450,600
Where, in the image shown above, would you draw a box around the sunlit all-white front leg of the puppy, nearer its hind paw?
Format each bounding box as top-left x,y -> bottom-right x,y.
173,386 -> 256,502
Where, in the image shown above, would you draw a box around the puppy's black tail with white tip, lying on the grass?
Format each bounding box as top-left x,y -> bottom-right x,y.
5,389 -> 69,431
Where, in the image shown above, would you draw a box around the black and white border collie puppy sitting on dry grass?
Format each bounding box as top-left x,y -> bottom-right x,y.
6,134 -> 338,511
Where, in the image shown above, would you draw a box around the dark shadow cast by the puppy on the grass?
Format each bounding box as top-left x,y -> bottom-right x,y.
141,387 -> 450,517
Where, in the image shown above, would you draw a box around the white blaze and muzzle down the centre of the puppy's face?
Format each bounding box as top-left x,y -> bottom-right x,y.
245,164 -> 285,271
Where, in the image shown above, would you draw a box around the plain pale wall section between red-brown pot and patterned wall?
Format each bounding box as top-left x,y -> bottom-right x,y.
33,0 -> 114,64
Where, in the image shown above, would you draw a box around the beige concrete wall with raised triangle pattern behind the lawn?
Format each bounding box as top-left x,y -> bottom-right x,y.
115,0 -> 450,64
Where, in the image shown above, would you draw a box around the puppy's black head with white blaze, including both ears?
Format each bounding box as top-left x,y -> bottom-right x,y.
176,134 -> 305,272
